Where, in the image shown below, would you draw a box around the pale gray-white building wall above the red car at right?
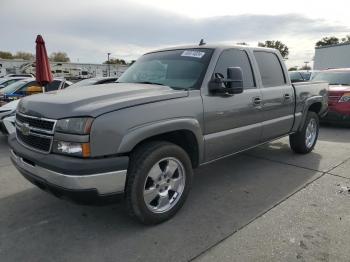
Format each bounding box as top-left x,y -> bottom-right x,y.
314,43 -> 350,70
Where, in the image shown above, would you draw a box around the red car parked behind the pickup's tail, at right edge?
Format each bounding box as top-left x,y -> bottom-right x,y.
312,68 -> 350,122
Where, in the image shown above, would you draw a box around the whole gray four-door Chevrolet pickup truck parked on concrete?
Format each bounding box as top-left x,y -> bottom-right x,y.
9,45 -> 328,224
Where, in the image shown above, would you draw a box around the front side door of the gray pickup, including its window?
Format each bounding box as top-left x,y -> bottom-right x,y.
202,49 -> 262,161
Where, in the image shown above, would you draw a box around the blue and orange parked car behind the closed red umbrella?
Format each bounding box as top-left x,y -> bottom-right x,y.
0,78 -> 72,105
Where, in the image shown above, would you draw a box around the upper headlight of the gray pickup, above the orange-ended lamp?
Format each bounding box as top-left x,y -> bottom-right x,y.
55,117 -> 93,135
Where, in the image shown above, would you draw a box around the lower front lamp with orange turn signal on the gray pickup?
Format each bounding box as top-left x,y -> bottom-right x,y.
53,141 -> 90,157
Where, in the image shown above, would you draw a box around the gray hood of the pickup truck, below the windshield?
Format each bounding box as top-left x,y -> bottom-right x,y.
17,83 -> 188,119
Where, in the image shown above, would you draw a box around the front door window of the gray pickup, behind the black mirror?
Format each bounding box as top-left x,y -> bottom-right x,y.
215,49 -> 255,89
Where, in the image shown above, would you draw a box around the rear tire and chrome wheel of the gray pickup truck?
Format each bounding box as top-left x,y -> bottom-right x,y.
289,111 -> 320,154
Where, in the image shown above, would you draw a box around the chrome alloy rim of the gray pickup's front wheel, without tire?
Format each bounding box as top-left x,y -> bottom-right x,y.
143,157 -> 186,213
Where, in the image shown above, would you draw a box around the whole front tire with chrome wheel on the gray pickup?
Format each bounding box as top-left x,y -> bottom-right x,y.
126,141 -> 193,224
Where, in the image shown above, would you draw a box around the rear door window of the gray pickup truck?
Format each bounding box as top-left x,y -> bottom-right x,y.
254,51 -> 286,87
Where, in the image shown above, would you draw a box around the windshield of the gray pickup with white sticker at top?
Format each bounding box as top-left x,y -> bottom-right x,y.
118,48 -> 213,89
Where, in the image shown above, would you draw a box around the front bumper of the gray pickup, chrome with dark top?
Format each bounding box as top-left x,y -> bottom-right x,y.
9,135 -> 128,204
